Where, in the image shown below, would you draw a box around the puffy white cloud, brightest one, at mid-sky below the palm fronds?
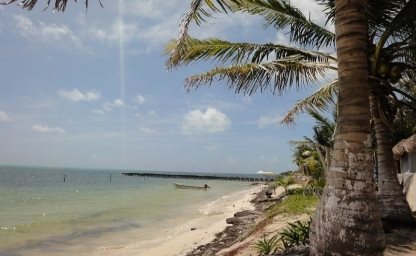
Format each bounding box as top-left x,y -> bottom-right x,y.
182,108 -> 231,134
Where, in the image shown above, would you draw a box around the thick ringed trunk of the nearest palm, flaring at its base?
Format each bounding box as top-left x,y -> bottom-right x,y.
310,0 -> 384,256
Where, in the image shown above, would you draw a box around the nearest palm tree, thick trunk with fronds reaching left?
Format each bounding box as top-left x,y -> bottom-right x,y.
168,0 -> 384,252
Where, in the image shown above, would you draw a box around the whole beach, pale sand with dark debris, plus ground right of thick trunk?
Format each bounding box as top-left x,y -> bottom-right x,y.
92,182 -> 416,256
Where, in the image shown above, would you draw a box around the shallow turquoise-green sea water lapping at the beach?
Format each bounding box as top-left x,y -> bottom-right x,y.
0,166 -> 248,256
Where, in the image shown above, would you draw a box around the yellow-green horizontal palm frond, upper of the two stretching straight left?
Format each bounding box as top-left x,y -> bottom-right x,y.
165,38 -> 336,66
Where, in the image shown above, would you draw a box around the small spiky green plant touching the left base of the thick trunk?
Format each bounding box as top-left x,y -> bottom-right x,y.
279,220 -> 311,249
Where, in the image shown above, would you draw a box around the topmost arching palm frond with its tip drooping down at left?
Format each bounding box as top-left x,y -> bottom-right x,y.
167,0 -> 335,68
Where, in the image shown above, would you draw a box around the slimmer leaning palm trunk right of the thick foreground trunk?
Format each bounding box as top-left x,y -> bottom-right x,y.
370,90 -> 415,224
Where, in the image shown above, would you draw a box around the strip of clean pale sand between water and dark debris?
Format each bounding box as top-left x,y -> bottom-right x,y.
93,185 -> 264,256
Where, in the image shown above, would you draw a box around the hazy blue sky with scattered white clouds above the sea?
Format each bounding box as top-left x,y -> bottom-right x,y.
0,0 -> 334,173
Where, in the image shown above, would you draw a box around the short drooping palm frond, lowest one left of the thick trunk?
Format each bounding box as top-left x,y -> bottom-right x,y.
282,80 -> 338,124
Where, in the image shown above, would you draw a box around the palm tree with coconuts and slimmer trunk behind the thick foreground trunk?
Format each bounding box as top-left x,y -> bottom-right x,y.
284,1 -> 416,224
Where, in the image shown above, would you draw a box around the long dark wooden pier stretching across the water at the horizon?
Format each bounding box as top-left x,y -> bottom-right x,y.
123,172 -> 275,182
